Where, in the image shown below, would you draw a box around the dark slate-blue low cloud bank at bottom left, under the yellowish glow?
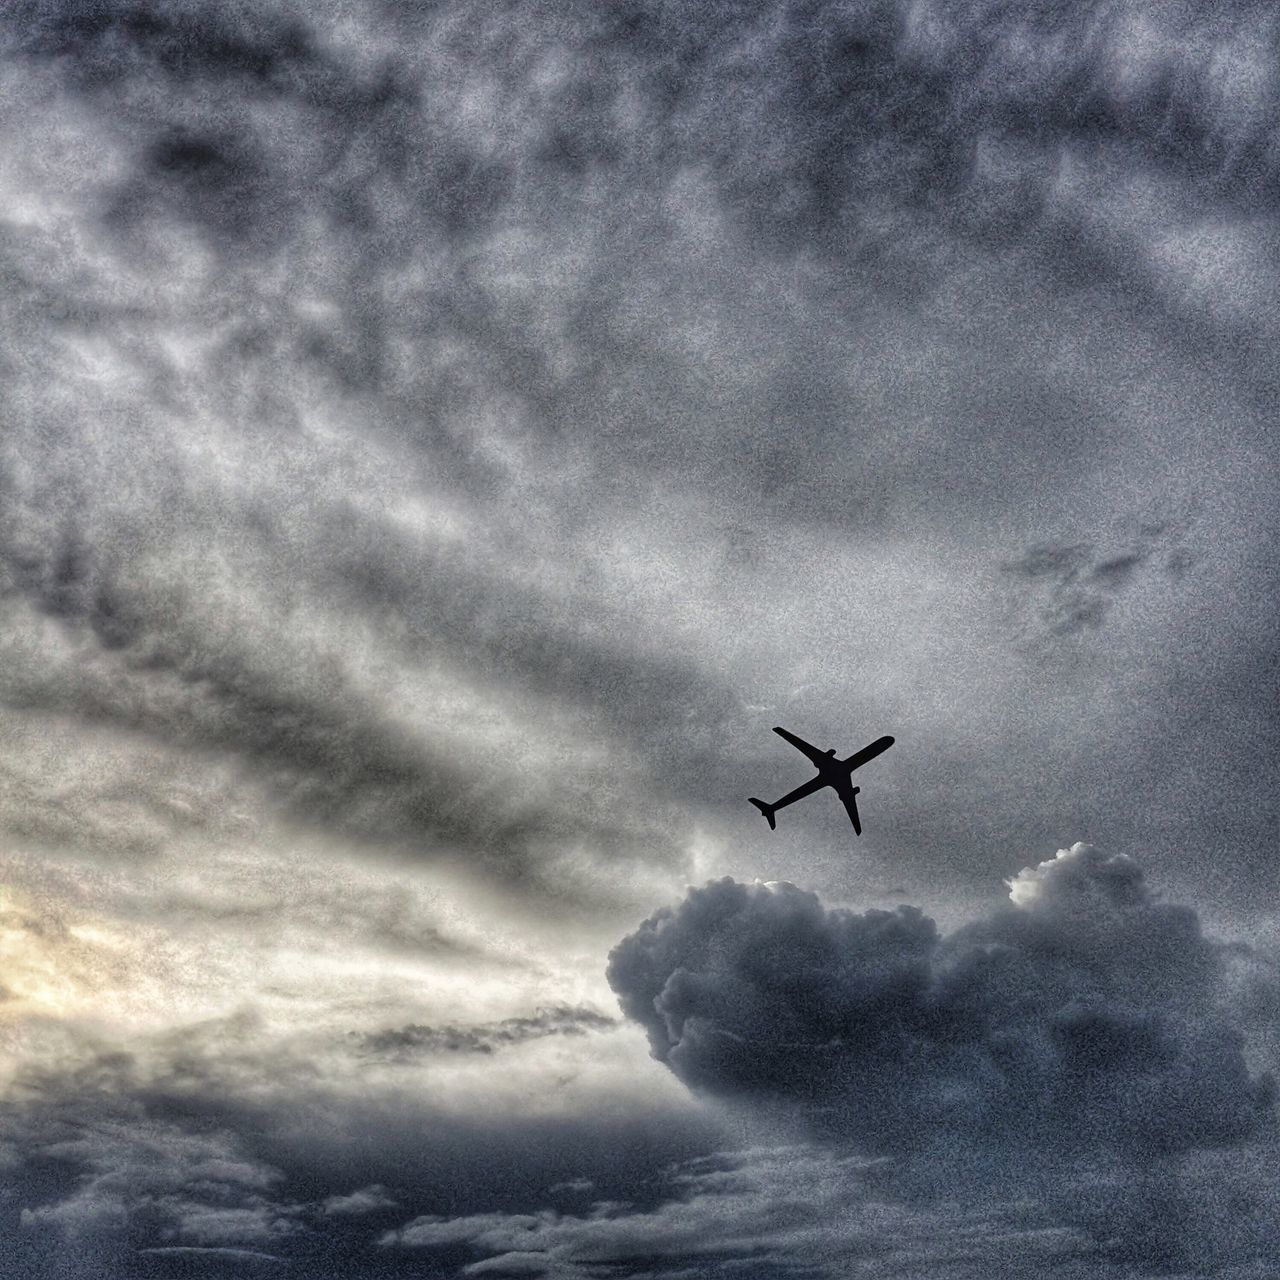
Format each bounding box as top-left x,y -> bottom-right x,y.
0,1036 -> 717,1280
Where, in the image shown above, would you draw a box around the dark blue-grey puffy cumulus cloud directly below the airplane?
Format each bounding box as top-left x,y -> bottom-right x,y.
609,845 -> 1275,1160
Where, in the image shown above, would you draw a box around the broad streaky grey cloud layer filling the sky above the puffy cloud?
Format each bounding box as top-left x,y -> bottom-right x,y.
0,0 -> 1277,910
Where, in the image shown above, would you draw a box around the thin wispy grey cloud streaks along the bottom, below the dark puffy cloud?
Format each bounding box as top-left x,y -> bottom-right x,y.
381,1148 -> 1119,1280
